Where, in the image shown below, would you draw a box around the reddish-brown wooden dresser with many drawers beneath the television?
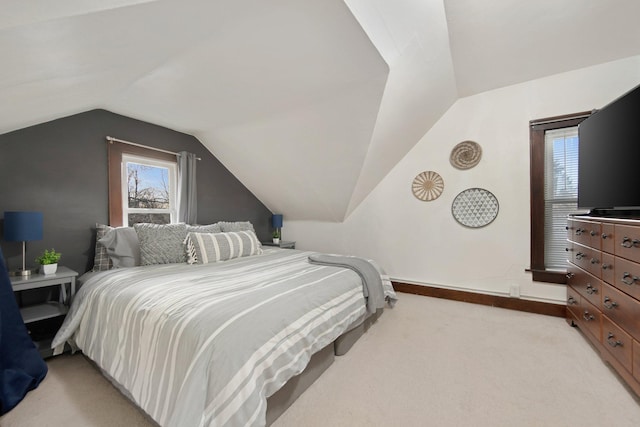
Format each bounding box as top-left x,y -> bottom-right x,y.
567,216 -> 640,396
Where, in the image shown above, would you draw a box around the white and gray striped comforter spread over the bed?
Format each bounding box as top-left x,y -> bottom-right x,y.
52,250 -> 393,427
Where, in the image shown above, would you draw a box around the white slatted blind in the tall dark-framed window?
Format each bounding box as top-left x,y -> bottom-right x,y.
544,126 -> 578,270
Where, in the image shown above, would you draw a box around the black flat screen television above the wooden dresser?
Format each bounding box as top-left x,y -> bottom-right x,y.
578,86 -> 640,217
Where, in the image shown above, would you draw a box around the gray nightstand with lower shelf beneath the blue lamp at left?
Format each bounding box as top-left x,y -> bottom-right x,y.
11,266 -> 78,357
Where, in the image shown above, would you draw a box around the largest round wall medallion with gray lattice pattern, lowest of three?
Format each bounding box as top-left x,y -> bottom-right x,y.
451,188 -> 499,228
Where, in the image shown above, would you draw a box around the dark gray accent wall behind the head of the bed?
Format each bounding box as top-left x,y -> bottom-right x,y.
0,110 -> 271,273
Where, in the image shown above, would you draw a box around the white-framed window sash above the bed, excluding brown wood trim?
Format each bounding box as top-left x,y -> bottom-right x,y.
122,154 -> 177,226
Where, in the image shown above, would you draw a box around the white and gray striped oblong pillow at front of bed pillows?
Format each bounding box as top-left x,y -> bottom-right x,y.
186,230 -> 262,264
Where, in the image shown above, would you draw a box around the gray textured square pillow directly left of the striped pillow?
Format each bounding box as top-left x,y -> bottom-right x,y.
133,223 -> 187,265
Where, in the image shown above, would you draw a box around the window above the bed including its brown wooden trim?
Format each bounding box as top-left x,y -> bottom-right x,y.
108,142 -> 178,227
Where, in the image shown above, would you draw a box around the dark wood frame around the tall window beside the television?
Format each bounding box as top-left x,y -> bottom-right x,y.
528,111 -> 591,284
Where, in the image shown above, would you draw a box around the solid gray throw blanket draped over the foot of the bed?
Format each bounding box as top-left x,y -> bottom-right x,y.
309,254 -> 384,313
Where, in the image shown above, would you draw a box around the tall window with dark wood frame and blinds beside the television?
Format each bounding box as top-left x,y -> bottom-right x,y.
530,112 -> 590,283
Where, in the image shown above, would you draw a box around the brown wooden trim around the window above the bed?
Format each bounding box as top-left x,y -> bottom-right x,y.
107,141 -> 178,227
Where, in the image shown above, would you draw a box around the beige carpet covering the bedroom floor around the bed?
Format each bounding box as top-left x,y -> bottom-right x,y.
0,294 -> 640,427
